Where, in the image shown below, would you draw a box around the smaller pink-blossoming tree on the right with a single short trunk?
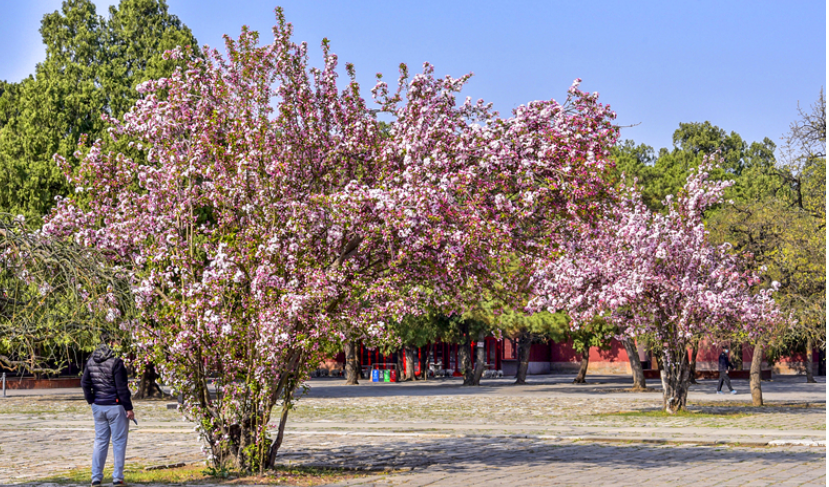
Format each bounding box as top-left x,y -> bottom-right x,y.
531,161 -> 786,412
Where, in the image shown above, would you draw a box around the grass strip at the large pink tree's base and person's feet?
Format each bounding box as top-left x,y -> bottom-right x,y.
41,464 -> 378,487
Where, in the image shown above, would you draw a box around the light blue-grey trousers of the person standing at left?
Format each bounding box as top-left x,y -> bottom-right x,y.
92,404 -> 130,482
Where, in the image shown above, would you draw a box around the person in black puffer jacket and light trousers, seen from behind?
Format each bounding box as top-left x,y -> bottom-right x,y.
81,337 -> 135,486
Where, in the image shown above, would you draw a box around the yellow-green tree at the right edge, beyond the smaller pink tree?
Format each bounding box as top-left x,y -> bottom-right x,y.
708,92 -> 826,382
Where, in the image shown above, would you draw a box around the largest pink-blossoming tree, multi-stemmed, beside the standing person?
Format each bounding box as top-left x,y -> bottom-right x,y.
45,10 -> 617,471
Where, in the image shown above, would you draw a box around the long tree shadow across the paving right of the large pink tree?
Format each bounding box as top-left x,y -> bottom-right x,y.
279,437 -> 826,470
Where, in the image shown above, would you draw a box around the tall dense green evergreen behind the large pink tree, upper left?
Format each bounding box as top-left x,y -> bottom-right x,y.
0,0 -> 196,225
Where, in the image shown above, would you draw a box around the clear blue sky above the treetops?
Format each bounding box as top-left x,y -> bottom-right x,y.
0,0 -> 826,149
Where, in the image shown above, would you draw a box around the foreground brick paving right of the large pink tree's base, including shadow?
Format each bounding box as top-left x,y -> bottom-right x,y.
283,437 -> 826,487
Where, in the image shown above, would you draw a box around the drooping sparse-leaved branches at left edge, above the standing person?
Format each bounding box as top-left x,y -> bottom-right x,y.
0,213 -> 135,373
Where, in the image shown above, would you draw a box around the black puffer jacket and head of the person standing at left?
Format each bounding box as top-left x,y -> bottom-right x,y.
81,345 -> 132,411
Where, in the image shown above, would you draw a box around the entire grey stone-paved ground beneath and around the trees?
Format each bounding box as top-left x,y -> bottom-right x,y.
0,376 -> 826,487
